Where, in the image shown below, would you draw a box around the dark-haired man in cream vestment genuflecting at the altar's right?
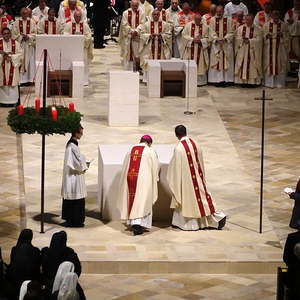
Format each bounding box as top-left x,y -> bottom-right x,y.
167,125 -> 226,230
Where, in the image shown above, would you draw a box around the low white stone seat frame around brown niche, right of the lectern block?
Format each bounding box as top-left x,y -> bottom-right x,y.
147,58 -> 197,98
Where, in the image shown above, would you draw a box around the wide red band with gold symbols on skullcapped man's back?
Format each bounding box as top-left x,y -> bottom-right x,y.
127,146 -> 145,217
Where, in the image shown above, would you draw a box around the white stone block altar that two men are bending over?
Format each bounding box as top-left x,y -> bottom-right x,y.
98,144 -> 174,220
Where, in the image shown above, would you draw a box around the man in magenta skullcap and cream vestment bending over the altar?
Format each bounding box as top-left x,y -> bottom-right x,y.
118,135 -> 159,235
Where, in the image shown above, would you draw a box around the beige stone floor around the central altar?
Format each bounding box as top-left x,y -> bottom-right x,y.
0,41 -> 300,299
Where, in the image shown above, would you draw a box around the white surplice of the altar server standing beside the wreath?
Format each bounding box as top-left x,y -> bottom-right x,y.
61,139 -> 88,200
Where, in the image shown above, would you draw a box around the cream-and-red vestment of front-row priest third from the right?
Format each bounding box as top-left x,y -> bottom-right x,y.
208,17 -> 234,83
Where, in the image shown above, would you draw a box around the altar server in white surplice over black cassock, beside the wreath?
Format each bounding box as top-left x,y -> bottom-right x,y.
61,126 -> 89,227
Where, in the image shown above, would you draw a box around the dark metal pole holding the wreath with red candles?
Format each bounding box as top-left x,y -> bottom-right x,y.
41,49 -> 48,233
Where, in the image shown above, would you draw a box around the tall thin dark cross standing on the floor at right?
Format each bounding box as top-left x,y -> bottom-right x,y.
255,90 -> 273,233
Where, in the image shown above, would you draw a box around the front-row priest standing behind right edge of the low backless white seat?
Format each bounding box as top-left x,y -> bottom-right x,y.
181,14 -> 209,86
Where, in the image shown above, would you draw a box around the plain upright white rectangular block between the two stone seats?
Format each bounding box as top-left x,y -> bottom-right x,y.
108,71 -> 140,126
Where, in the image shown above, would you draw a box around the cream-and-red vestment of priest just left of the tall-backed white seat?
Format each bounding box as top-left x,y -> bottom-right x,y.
12,18 -> 37,83
